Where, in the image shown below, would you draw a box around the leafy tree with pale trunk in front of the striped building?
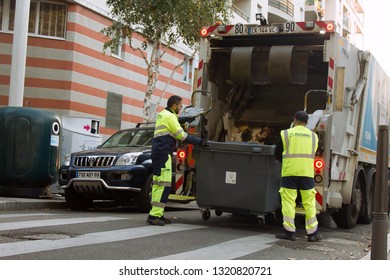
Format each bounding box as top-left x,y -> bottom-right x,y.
101,0 -> 231,121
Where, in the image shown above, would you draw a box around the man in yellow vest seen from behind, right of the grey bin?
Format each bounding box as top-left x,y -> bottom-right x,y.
275,111 -> 322,242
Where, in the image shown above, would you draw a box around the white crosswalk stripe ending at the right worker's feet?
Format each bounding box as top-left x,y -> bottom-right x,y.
156,234 -> 277,260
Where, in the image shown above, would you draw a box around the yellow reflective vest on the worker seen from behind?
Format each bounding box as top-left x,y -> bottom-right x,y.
280,125 -> 318,178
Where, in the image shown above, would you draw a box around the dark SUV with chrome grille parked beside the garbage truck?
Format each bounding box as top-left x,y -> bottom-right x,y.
59,126 -> 154,212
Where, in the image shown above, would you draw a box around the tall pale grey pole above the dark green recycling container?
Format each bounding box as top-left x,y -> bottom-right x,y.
8,0 -> 30,107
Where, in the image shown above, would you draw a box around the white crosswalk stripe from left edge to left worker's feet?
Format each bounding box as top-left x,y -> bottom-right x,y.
0,224 -> 205,257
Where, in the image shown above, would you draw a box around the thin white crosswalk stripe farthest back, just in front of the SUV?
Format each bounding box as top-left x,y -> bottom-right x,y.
0,217 -> 128,231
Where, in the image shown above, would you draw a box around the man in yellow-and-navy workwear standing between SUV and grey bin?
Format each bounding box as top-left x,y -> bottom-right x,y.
147,95 -> 207,226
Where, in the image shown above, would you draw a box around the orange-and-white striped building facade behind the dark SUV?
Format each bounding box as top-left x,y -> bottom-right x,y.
0,0 -> 192,136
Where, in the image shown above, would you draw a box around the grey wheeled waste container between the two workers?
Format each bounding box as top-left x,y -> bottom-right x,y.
194,142 -> 281,220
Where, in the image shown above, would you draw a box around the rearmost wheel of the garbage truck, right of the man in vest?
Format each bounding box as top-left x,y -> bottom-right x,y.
332,176 -> 362,228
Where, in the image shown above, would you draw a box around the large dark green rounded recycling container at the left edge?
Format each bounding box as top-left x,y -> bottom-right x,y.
0,107 -> 61,197
